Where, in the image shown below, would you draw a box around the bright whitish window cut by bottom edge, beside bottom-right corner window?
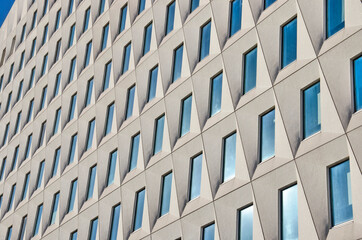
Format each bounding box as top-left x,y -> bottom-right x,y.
281,185 -> 298,240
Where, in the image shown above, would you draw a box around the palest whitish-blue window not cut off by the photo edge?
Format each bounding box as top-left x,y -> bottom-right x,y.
223,133 -> 236,182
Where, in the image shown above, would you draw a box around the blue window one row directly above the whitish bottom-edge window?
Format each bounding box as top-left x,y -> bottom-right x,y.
260,110 -> 275,161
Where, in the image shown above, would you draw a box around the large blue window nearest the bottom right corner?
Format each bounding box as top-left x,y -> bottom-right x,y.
329,161 -> 353,226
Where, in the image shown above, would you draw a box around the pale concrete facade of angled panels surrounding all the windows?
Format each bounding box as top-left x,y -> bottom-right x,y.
0,0 -> 362,240
